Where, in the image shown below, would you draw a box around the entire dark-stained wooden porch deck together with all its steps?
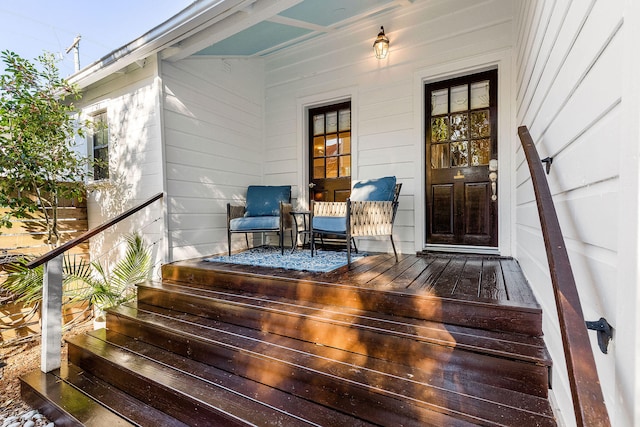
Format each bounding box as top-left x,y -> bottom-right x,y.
17,254 -> 555,427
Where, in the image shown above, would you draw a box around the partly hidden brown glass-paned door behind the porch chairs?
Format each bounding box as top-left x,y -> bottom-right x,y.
309,102 -> 351,202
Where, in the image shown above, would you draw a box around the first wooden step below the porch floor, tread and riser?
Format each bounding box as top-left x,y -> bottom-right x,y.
138,283 -> 551,398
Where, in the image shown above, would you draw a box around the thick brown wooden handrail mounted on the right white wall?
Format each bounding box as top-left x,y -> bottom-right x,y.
518,126 -> 611,426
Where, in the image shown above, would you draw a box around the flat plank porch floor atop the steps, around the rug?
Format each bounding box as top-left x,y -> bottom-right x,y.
173,253 -> 539,308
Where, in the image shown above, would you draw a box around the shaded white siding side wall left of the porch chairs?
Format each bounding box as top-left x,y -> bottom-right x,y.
162,57 -> 265,260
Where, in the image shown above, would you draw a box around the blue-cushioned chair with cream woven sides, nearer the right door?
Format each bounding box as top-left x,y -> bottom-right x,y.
311,176 -> 402,264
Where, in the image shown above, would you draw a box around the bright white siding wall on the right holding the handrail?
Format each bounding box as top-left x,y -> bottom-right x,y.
515,0 -> 640,426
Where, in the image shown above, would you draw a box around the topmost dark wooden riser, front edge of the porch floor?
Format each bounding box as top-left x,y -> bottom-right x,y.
162,264 -> 542,336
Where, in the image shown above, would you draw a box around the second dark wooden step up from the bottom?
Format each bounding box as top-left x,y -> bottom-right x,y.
69,330 -> 472,426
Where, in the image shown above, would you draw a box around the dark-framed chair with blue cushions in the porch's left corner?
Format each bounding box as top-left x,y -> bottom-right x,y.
227,185 -> 293,256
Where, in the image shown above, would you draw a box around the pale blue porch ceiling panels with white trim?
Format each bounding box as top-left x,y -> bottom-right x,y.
164,0 -> 414,60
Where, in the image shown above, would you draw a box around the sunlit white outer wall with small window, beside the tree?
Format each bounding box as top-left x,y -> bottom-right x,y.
80,57 -> 164,278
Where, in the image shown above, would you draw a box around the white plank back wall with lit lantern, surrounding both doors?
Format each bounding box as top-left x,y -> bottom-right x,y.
264,0 -> 515,253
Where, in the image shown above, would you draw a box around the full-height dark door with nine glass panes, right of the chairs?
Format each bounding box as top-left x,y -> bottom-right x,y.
425,70 -> 498,247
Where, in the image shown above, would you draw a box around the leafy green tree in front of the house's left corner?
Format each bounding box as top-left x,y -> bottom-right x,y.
0,51 -> 91,245
